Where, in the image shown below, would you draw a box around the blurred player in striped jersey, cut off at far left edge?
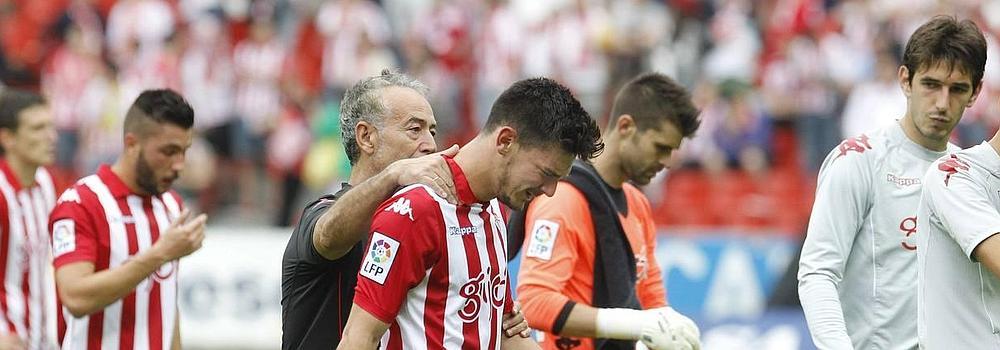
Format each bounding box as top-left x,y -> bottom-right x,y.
0,88 -> 56,349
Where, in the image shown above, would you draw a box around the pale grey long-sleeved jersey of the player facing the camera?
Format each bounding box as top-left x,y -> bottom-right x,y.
798,122 -> 958,349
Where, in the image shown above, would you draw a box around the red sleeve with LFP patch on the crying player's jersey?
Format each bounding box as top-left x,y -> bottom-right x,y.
354,188 -> 444,324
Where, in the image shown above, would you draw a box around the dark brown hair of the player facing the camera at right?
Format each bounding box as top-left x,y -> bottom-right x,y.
903,15 -> 986,91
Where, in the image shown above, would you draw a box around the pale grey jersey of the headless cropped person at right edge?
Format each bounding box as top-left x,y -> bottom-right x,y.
917,142 -> 1000,349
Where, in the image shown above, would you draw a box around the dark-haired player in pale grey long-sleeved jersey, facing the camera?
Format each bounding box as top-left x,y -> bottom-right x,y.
798,16 -> 986,349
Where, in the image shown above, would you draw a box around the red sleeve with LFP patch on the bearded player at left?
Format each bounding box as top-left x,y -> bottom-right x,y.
49,188 -> 98,269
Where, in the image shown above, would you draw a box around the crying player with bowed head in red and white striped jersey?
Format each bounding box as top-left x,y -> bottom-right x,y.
339,78 -> 603,350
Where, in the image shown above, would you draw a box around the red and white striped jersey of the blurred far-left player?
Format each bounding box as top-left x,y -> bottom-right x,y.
0,160 -> 56,349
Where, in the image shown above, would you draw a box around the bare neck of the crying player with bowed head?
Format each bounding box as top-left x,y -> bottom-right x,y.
455,136 -> 500,201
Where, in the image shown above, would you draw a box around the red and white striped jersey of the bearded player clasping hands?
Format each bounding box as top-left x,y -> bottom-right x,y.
49,165 -> 183,350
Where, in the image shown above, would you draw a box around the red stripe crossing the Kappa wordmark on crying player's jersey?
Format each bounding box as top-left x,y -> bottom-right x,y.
455,206 -> 482,347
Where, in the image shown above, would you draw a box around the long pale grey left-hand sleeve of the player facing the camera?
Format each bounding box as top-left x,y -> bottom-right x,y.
798,137 -> 872,349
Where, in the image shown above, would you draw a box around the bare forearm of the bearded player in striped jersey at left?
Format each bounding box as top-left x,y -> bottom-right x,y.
56,250 -> 166,317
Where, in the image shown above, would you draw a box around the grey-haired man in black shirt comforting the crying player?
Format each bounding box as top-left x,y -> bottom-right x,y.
281,70 -> 528,350
